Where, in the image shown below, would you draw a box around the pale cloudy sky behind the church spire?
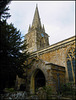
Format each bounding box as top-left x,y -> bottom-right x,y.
7,1 -> 75,45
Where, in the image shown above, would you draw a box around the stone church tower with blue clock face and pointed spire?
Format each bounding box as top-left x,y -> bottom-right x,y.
25,5 -> 49,52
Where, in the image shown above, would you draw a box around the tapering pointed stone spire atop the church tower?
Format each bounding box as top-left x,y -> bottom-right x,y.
32,4 -> 41,28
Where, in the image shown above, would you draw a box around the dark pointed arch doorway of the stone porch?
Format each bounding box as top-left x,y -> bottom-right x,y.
30,69 -> 46,94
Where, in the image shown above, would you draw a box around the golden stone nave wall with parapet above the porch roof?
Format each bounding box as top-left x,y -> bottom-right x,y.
31,37 -> 75,82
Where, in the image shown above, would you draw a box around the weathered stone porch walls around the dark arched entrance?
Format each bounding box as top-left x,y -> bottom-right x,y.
28,59 -> 65,93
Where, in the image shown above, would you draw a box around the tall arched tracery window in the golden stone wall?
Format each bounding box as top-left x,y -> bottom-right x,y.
67,48 -> 76,82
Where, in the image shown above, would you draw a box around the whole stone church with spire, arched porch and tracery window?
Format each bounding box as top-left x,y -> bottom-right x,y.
18,6 -> 76,93
